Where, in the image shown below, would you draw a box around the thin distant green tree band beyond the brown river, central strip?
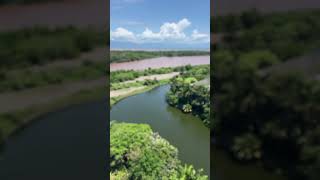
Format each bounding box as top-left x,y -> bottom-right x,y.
110,51 -> 210,63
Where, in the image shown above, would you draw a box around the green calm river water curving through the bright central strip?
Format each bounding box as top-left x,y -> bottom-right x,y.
110,85 -> 210,174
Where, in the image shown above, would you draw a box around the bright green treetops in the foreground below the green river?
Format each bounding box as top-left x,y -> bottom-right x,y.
110,121 -> 208,180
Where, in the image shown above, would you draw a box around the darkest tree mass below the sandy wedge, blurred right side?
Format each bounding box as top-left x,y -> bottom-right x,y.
213,47 -> 320,177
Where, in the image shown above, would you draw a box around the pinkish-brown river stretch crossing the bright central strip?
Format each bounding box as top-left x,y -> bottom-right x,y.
110,56 -> 210,71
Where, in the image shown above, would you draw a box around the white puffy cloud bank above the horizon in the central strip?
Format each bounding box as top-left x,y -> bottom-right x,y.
111,18 -> 210,43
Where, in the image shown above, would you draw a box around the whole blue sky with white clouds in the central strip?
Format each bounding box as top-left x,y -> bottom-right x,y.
110,0 -> 210,49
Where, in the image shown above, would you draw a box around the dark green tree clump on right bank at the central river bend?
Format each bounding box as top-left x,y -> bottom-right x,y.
166,66 -> 211,127
